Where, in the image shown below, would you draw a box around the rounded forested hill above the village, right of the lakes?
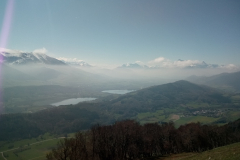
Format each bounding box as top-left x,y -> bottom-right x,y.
111,80 -> 231,115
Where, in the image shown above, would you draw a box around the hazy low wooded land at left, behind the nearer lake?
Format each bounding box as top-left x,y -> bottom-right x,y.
2,85 -> 107,114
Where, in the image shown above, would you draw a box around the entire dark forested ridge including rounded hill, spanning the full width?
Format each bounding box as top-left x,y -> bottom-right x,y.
0,81 -> 240,140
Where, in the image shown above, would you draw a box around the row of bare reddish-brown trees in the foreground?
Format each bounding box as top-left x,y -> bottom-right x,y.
46,119 -> 240,160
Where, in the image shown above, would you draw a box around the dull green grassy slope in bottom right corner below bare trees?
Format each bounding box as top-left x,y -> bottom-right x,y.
158,143 -> 240,160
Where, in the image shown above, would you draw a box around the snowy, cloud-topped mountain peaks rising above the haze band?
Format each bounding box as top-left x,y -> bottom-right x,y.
0,49 -> 237,69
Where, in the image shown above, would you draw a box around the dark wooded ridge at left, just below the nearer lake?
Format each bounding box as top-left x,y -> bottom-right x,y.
0,106 -> 108,141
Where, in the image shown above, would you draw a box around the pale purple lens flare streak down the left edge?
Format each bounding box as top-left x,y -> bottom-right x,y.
0,0 -> 14,114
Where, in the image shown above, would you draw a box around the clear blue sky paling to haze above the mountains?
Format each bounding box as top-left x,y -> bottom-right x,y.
0,0 -> 240,65
